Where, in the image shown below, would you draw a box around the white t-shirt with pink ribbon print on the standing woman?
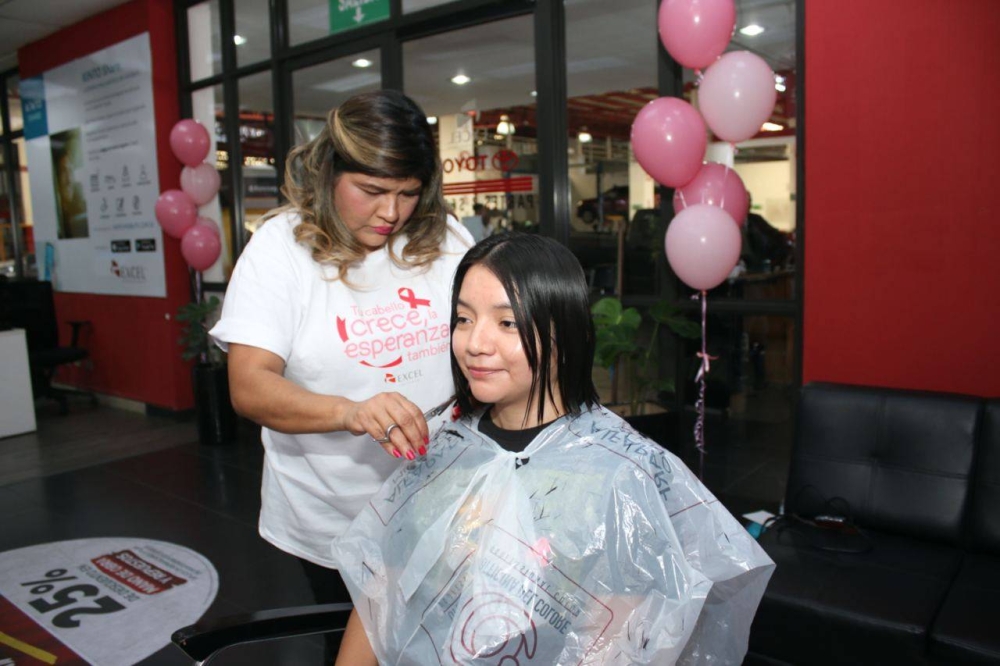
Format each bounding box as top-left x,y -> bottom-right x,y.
210,214 -> 472,567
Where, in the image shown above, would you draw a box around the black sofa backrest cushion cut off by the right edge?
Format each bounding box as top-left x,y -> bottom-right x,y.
969,400 -> 1000,555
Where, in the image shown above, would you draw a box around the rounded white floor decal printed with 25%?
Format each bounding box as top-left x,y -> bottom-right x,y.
0,538 -> 219,666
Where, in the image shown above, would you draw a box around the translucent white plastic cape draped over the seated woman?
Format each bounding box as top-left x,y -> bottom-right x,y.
333,408 -> 774,666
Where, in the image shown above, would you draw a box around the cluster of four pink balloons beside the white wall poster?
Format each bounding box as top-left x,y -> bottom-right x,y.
156,119 -> 222,271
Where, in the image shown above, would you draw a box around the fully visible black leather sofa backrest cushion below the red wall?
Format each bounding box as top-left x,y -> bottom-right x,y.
785,384 -> 982,543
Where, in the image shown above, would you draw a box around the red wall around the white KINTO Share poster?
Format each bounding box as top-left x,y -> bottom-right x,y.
18,0 -> 194,409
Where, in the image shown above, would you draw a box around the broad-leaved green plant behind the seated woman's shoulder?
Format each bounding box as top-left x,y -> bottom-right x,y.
591,296 -> 701,443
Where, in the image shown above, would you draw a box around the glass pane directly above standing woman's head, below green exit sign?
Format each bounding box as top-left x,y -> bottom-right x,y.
292,50 -> 382,145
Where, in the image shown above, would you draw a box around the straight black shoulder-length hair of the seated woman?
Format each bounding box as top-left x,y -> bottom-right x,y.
451,233 -> 598,422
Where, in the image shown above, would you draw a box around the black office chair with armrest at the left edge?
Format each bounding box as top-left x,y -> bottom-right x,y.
0,280 -> 97,414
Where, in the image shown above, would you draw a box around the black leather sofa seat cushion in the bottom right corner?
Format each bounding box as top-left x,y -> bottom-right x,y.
930,554 -> 1000,665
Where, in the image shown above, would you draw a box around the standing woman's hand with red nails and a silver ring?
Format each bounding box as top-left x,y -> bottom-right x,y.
343,393 -> 429,460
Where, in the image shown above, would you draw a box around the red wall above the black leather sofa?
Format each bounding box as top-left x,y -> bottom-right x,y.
803,0 -> 1000,396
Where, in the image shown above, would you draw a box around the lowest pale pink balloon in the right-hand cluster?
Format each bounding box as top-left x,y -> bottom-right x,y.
664,204 -> 741,291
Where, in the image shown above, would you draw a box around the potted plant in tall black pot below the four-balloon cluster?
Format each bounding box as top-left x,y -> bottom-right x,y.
177,296 -> 236,445
